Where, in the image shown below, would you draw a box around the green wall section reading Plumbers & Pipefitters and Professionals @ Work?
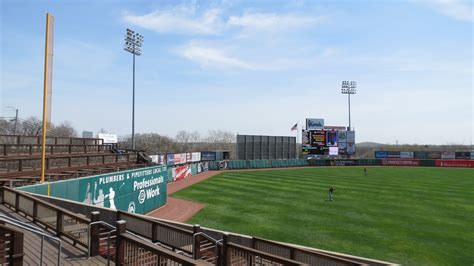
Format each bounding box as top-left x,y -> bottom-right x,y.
19,166 -> 168,214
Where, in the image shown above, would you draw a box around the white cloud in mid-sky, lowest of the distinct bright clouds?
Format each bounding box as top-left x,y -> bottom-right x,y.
178,43 -> 255,70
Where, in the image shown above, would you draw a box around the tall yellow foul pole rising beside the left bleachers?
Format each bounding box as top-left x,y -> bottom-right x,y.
40,13 -> 54,184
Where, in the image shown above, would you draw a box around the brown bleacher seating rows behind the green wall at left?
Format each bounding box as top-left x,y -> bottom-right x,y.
0,135 -> 151,186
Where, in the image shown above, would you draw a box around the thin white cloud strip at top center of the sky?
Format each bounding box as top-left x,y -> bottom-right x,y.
227,13 -> 322,31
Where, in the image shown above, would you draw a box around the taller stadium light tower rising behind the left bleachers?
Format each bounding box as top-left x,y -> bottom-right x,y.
123,29 -> 143,150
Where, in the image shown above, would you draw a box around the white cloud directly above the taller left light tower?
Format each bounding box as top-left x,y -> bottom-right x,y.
123,5 -> 222,35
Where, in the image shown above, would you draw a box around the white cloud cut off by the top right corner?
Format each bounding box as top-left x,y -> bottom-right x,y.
429,0 -> 474,22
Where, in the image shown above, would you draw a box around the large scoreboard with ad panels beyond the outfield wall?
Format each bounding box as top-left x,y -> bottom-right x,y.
301,119 -> 355,155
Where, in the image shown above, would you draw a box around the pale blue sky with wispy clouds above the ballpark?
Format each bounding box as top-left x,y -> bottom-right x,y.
0,0 -> 474,144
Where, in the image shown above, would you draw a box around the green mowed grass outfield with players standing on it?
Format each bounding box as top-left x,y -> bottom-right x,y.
173,167 -> 474,265
